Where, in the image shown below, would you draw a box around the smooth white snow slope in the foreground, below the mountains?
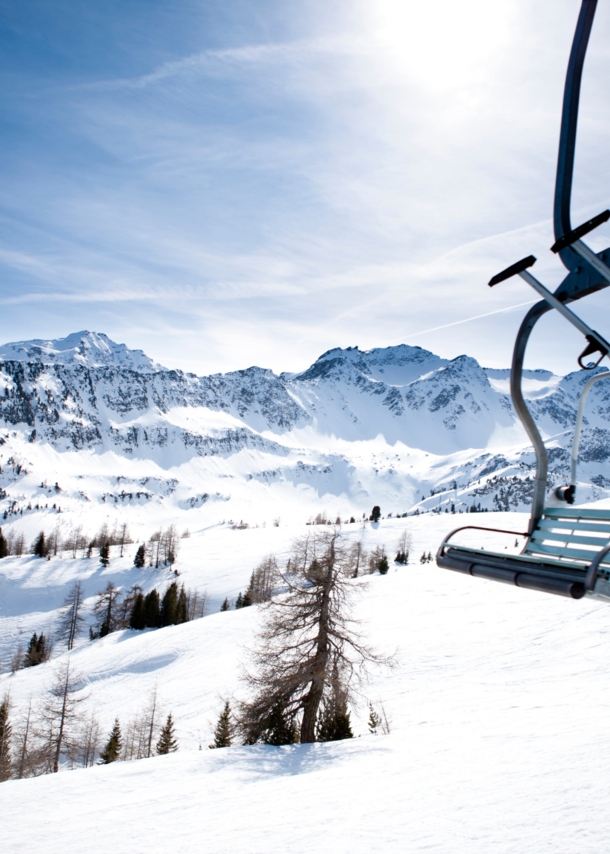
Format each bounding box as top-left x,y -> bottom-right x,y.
0,513 -> 610,854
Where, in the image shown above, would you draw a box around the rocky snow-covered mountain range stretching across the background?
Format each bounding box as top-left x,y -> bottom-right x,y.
0,332 -> 610,536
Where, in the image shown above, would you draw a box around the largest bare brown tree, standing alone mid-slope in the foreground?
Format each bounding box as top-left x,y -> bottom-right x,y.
239,530 -> 388,743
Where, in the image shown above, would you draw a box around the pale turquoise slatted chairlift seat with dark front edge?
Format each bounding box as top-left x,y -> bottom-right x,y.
436,507 -> 610,601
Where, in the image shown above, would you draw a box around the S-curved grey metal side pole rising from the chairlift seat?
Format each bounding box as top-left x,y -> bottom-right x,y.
510,300 -> 551,535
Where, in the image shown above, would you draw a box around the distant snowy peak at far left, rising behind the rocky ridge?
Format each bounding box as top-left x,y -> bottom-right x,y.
0,330 -> 162,373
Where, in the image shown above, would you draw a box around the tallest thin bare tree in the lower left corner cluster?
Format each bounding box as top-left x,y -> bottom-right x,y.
42,659 -> 87,773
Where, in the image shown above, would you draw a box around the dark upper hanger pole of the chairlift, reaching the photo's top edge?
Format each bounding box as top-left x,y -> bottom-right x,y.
553,0 -> 597,270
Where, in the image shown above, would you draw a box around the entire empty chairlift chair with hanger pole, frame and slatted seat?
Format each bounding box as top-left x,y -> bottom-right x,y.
436,0 -> 610,601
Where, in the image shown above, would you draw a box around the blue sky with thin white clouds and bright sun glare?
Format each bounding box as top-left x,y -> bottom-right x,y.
0,0 -> 610,373
